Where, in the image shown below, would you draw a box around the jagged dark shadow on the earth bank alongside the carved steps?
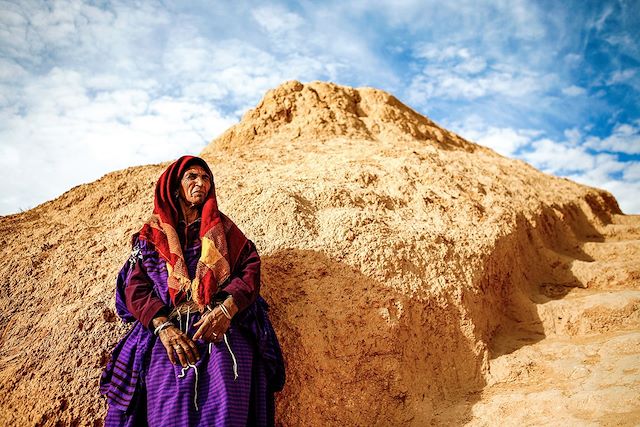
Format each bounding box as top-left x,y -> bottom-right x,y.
436,193 -> 620,424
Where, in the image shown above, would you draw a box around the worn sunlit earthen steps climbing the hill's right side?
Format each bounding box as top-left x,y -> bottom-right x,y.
464,215 -> 640,426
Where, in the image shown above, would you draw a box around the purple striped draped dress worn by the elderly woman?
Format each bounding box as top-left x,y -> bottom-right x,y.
100,236 -> 284,427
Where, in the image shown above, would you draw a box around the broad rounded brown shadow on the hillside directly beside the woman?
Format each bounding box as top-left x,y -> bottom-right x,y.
263,249 -> 484,426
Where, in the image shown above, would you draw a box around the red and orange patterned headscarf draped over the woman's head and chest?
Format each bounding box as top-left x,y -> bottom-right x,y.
140,156 -> 247,308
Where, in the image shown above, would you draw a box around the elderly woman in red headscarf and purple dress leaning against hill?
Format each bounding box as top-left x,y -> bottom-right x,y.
100,156 -> 284,426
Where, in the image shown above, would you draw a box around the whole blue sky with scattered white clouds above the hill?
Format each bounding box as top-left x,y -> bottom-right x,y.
0,0 -> 640,215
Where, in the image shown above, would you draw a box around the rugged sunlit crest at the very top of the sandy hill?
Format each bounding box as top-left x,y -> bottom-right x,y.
202,81 -> 477,156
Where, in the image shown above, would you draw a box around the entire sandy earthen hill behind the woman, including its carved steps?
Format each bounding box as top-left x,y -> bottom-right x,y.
0,82 -> 640,426
